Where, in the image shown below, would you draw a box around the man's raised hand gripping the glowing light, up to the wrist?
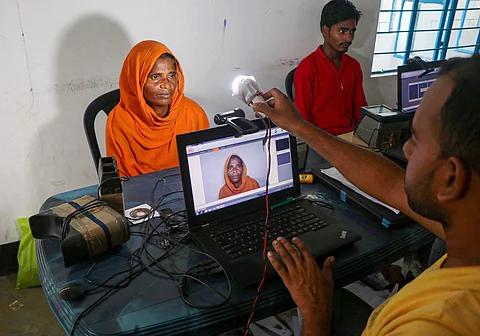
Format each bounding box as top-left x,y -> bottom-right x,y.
253,89 -> 305,137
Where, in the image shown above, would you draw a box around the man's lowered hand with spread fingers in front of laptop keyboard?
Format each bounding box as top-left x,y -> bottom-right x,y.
268,237 -> 334,335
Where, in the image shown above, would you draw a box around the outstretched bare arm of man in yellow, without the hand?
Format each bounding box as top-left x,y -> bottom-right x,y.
292,121 -> 445,239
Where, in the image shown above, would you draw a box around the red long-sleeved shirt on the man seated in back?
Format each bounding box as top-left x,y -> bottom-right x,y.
294,47 -> 367,135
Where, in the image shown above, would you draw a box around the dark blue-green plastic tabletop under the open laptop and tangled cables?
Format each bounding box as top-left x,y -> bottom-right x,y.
35,168 -> 434,335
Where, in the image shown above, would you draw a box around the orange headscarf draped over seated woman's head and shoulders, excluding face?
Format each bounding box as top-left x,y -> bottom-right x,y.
105,41 -> 209,176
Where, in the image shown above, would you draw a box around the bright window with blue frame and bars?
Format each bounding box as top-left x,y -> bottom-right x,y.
372,0 -> 480,74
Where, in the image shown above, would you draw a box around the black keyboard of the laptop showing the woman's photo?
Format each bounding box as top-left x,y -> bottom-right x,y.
210,205 -> 328,258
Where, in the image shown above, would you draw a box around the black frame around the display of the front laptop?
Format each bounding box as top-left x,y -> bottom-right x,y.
177,119 -> 300,230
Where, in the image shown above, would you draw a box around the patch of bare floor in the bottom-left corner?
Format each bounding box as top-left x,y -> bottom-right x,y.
0,273 -> 65,336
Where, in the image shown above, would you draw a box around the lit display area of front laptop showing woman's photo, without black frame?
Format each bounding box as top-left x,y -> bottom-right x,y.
186,127 -> 293,215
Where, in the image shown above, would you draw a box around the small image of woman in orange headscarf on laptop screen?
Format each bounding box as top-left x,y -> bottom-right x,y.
218,154 -> 260,199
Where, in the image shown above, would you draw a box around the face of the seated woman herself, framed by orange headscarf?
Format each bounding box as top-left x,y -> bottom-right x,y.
143,58 -> 178,110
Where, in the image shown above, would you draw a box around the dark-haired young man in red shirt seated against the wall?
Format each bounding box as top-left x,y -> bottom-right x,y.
294,0 -> 367,135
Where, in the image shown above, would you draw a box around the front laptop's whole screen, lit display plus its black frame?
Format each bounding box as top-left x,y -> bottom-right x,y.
177,119 -> 300,224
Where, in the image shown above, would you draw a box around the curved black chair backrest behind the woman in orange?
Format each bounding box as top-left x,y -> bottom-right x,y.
83,89 -> 120,174
